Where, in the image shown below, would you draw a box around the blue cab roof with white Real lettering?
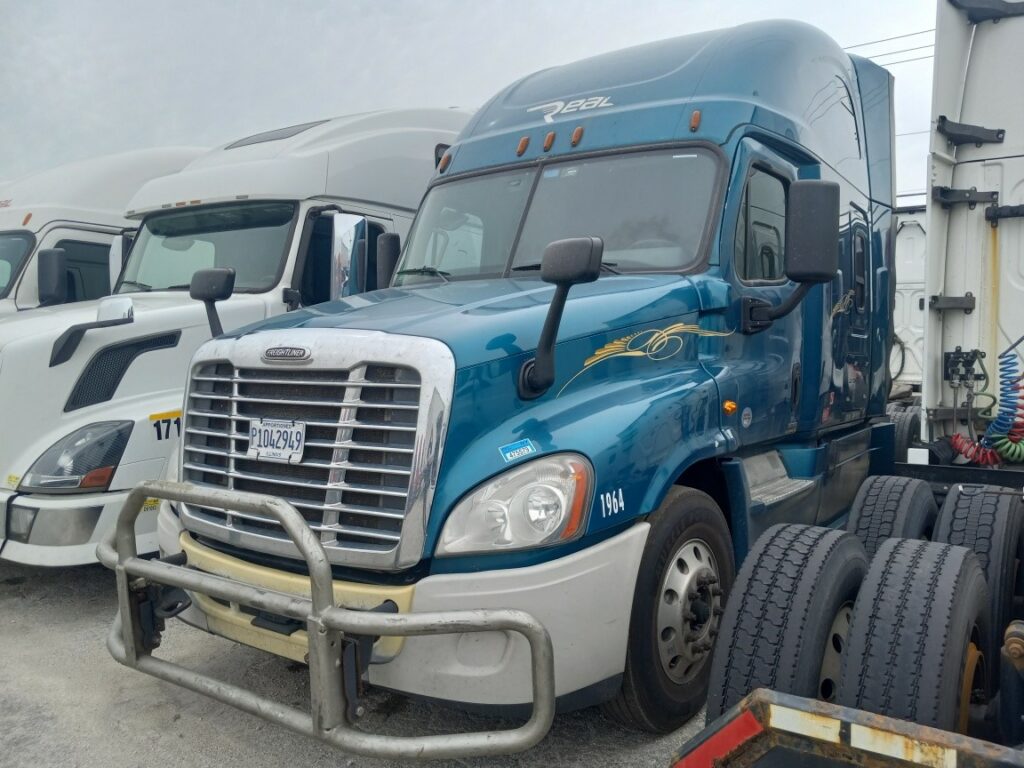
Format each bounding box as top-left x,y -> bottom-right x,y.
445,20 -> 892,203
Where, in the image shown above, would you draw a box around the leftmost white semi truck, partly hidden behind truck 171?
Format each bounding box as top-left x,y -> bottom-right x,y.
0,146 -> 205,317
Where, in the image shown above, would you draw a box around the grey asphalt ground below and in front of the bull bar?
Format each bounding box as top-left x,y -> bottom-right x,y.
0,562 -> 702,768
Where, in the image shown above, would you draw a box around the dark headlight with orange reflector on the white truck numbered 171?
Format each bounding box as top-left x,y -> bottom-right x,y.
19,421 -> 133,494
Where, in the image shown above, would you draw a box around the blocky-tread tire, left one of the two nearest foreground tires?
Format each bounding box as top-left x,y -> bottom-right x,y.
708,525 -> 867,721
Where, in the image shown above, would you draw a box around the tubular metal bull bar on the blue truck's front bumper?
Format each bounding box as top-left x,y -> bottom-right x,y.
96,481 -> 555,759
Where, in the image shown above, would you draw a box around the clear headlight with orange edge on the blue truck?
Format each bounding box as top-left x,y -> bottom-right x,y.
437,454 -> 594,557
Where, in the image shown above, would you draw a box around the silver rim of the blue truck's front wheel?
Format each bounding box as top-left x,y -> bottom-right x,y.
655,539 -> 722,683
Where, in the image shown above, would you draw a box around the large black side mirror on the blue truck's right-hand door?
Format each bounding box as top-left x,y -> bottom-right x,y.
785,179 -> 839,284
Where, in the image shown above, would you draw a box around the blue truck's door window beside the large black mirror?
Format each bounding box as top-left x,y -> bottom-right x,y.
735,169 -> 785,283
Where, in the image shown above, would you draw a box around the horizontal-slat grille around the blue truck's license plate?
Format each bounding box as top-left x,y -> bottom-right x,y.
181,361 -> 421,561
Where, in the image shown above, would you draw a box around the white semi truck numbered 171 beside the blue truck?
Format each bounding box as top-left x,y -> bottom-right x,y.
0,110 -> 467,565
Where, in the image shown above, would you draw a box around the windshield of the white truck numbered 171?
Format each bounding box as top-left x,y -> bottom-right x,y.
117,203 -> 297,293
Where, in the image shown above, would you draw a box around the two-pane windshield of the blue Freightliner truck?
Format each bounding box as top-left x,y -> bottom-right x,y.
395,148 -> 717,286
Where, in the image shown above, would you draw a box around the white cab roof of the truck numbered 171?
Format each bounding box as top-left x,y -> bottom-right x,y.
128,109 -> 468,218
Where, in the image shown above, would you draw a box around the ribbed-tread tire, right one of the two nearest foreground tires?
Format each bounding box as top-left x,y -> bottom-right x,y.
837,539 -> 989,733
